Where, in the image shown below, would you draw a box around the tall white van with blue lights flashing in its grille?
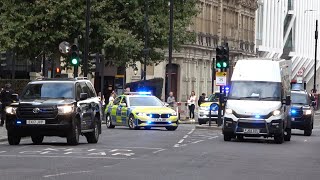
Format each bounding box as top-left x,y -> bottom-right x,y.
222,59 -> 291,144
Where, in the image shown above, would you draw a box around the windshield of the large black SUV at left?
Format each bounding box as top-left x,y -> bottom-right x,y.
21,83 -> 74,99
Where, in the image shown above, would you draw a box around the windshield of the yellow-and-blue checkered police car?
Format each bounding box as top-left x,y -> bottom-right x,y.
129,96 -> 163,106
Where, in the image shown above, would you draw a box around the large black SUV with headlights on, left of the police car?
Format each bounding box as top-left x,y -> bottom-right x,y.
6,78 -> 102,145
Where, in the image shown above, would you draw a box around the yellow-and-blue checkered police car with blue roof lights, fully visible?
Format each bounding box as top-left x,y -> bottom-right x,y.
105,92 -> 178,131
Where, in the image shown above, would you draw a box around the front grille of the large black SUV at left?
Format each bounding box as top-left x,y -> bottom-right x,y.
17,106 -> 58,119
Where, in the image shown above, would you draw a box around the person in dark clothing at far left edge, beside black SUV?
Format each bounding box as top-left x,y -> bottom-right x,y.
0,83 -> 14,126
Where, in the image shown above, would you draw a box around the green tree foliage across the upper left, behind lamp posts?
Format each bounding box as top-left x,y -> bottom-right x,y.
0,0 -> 198,71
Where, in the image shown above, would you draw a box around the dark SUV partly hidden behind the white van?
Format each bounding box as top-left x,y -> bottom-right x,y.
291,91 -> 315,136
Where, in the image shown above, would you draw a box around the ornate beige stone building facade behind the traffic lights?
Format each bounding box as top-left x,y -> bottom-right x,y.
126,0 -> 257,102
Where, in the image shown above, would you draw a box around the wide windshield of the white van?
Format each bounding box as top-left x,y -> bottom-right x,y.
229,81 -> 281,101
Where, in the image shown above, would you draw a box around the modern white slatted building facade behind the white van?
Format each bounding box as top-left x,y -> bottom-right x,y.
256,0 -> 320,91
